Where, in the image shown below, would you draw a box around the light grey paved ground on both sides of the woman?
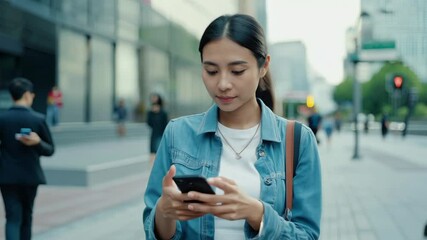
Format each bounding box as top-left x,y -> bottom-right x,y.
0,128 -> 427,240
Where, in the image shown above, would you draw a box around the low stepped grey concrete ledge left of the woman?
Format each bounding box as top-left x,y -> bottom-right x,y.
42,124 -> 151,186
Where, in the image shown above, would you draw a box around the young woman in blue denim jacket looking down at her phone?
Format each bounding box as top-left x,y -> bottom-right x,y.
143,14 -> 321,239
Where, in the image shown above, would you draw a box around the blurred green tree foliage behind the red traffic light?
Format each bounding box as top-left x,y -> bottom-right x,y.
362,62 -> 422,116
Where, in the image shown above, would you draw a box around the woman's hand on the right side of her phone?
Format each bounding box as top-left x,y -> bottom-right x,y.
188,177 -> 264,230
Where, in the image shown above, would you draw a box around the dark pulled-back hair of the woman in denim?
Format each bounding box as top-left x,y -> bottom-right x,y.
199,14 -> 274,110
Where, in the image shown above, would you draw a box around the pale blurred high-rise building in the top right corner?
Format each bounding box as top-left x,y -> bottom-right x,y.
361,0 -> 427,82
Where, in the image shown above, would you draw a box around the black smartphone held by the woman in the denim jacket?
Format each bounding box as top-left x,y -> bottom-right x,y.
173,176 -> 215,202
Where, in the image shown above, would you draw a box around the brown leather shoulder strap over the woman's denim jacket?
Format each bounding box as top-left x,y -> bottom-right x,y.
285,120 -> 301,221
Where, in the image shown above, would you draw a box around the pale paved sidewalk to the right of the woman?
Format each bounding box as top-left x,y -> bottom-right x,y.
319,130 -> 427,240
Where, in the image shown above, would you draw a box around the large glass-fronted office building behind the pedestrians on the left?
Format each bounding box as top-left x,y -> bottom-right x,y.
0,0 -> 211,122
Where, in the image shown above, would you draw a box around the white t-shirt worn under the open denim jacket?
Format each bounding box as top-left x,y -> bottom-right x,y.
215,123 -> 261,239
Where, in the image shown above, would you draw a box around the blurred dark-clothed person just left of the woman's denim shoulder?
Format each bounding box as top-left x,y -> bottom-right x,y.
147,93 -> 169,164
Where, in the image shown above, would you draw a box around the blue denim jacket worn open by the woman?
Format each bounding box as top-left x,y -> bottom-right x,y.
143,100 -> 321,239
